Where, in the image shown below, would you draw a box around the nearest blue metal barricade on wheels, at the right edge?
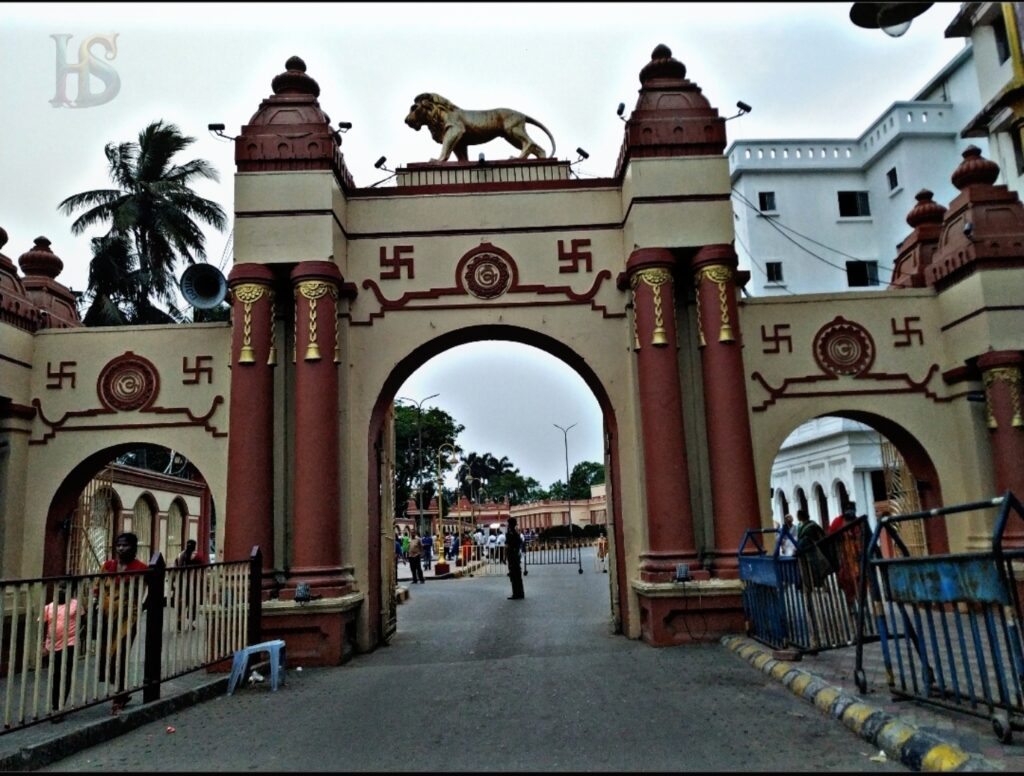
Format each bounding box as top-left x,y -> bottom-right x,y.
856,492 -> 1024,743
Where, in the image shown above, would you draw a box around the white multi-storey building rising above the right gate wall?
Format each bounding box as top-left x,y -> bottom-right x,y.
726,45 -> 987,296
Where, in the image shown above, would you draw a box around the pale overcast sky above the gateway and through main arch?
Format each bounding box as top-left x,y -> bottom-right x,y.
0,3 -> 964,485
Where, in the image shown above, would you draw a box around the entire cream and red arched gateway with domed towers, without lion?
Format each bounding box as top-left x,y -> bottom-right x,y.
0,46 -> 1024,664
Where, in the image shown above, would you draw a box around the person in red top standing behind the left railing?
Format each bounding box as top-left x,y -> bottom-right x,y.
92,532 -> 147,715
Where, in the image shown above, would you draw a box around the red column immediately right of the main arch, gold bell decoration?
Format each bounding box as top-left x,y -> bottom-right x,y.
626,248 -> 698,581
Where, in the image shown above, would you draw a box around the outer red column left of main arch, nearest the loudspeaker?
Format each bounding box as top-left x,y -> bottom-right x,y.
225,264 -> 278,571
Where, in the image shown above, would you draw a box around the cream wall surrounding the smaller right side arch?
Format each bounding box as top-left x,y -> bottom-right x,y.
740,290 -> 994,550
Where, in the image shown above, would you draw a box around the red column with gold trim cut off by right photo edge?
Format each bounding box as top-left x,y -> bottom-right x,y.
978,350 -> 1024,547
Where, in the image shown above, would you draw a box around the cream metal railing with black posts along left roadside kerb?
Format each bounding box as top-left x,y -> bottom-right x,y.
0,549 -> 262,735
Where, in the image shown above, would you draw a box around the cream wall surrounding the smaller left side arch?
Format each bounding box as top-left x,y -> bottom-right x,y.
9,324 -> 230,576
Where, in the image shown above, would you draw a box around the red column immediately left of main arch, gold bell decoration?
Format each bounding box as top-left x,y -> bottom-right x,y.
290,261 -> 342,596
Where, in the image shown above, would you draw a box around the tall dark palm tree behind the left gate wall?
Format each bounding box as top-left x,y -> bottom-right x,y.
57,120 -> 227,324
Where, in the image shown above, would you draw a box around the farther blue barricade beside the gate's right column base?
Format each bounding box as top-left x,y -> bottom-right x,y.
738,516 -> 878,652
